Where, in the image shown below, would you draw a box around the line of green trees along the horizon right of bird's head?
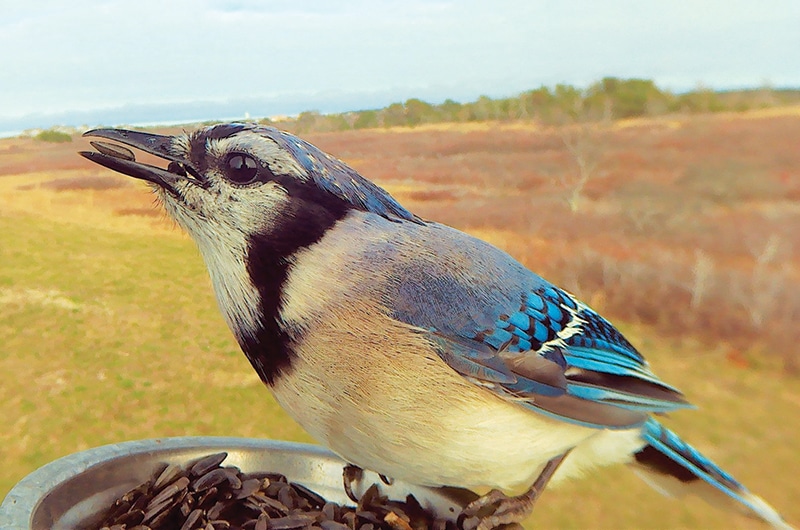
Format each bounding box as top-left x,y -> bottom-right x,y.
268,77 -> 800,133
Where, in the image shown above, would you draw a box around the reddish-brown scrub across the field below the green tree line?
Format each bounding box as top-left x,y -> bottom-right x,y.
6,107 -> 800,371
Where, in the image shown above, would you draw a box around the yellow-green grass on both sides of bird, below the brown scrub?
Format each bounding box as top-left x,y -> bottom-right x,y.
0,211 -> 800,528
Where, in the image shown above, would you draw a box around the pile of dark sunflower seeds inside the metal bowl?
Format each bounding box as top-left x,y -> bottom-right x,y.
87,453 -> 456,530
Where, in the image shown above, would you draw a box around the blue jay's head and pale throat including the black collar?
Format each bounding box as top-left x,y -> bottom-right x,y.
81,123 -> 419,380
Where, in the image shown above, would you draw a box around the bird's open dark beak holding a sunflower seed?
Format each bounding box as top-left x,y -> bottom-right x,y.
79,129 -> 204,193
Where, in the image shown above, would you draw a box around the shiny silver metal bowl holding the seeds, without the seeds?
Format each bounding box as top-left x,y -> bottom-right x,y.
0,437 -> 477,530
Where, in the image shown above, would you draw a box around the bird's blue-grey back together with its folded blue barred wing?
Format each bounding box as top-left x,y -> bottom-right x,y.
356,218 -> 689,428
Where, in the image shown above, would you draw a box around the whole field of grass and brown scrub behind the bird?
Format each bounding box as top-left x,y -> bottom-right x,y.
0,107 -> 800,529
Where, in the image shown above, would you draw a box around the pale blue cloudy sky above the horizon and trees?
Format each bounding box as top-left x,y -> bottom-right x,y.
0,0 -> 800,131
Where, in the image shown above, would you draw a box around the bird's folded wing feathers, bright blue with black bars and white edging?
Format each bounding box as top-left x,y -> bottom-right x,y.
416,280 -> 690,428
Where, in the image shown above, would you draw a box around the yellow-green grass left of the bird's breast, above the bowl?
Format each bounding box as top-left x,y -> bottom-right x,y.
0,209 -> 310,498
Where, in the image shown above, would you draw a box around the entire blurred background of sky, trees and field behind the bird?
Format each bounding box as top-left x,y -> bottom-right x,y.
0,0 -> 800,528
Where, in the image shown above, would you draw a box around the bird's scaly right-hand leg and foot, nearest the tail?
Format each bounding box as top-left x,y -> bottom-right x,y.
458,451 -> 569,530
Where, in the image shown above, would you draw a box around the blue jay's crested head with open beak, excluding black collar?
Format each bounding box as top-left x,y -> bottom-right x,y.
81,123 -> 413,243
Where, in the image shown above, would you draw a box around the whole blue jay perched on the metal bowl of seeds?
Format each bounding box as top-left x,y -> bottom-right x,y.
80,123 -> 791,530
